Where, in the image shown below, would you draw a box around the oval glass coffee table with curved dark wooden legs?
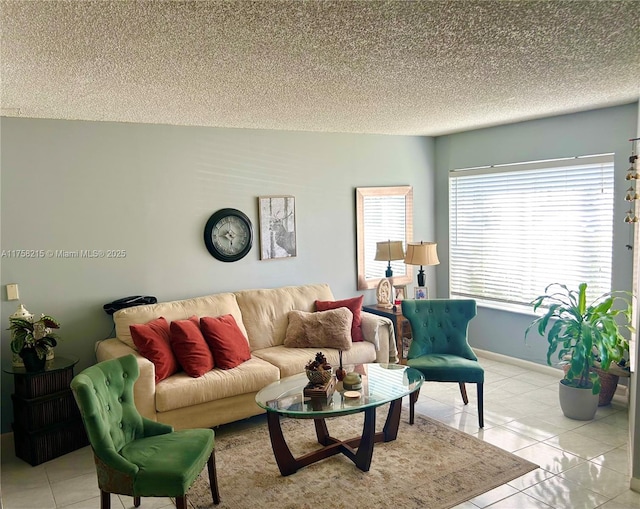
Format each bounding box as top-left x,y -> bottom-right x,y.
256,363 -> 424,475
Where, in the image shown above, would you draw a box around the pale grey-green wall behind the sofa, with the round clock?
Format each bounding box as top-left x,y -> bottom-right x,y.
0,118 -> 435,432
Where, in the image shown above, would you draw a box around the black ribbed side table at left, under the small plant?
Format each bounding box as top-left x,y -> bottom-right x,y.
2,357 -> 89,466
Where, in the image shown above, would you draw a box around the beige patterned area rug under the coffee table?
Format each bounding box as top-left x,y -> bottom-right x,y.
188,407 -> 537,509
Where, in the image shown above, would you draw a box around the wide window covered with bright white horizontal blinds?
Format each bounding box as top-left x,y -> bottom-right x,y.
449,154 -> 614,306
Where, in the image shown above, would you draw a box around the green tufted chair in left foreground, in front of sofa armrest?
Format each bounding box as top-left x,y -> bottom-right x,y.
71,355 -> 220,509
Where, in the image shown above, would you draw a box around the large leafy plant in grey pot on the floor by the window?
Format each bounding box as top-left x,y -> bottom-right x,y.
525,283 -> 633,420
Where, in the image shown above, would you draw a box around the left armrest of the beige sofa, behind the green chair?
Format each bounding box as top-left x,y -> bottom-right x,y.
96,338 -> 157,421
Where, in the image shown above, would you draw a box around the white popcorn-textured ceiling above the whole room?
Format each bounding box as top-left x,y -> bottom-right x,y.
0,0 -> 640,135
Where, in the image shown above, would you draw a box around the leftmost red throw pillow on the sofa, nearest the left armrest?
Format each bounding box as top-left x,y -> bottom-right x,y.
129,316 -> 180,383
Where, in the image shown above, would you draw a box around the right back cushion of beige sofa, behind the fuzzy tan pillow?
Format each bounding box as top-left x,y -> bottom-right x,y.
236,284 -> 333,351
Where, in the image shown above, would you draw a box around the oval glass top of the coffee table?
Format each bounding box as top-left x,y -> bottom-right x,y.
256,363 -> 424,419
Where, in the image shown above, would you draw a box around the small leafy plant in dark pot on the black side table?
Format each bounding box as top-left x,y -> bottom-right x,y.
8,313 -> 60,371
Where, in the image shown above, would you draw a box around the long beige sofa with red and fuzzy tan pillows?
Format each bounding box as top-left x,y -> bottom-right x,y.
96,284 -> 397,429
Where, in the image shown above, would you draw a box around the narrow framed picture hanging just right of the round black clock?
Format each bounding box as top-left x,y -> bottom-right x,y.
258,196 -> 297,260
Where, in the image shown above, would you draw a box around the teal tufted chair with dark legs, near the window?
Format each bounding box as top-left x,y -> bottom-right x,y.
402,299 -> 484,428
